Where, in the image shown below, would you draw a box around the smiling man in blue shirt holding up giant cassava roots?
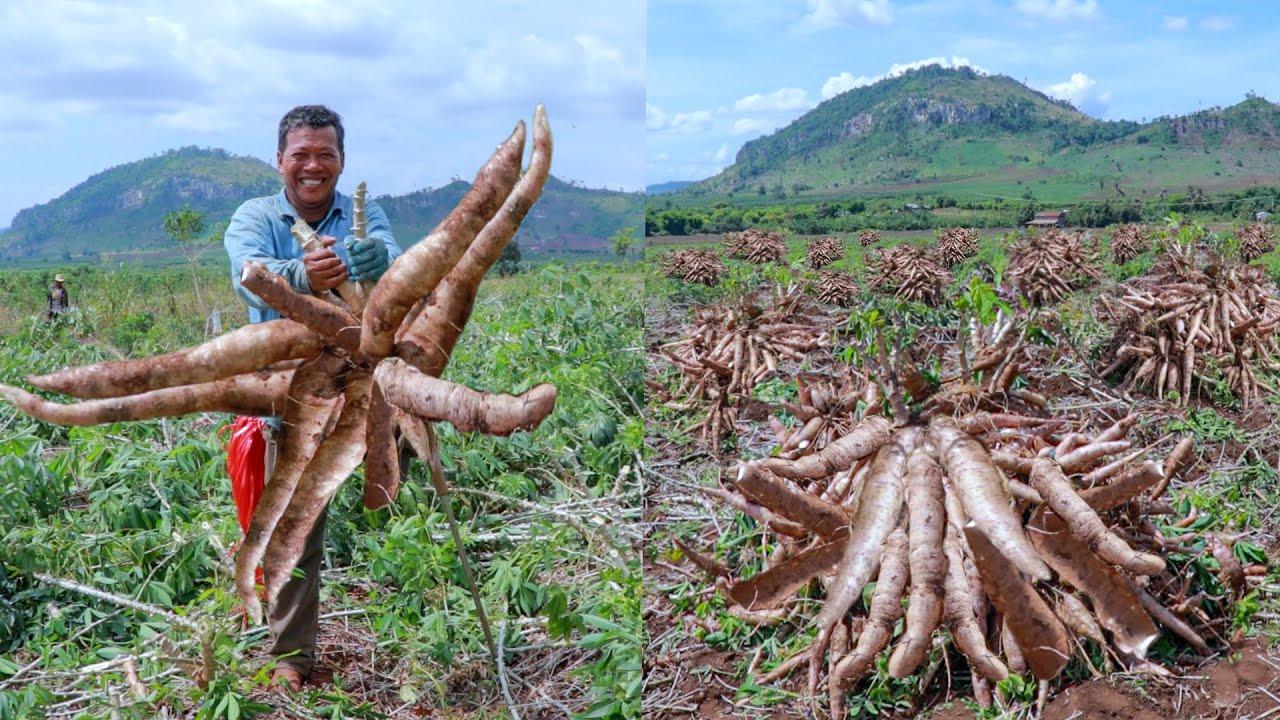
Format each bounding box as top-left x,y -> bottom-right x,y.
223,105 -> 401,691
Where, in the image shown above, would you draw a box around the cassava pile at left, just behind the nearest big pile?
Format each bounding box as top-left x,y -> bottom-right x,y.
658,293 -> 831,452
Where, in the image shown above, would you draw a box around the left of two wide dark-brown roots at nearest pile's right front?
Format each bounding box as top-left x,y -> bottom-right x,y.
964,520 -> 1071,680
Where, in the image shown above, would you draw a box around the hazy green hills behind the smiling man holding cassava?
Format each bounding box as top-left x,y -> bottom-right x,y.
0,146 -> 644,261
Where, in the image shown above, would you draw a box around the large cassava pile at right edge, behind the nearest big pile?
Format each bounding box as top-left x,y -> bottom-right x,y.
1098,252 -> 1280,410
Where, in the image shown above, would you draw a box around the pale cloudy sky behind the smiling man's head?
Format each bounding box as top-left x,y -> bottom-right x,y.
0,0 -> 645,227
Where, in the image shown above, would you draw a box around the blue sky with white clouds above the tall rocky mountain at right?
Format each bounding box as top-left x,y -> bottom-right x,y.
645,0 -> 1280,184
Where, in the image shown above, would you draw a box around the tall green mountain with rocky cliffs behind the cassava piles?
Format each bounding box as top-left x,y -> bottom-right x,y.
664,65 -> 1280,204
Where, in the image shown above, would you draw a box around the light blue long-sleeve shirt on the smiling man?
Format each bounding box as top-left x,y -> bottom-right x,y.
223,188 -> 401,323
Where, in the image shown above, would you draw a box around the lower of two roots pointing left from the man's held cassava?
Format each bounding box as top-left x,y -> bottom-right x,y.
0,370 -> 293,425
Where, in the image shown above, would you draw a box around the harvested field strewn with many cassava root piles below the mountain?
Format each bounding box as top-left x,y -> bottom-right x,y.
643,215 -> 1280,720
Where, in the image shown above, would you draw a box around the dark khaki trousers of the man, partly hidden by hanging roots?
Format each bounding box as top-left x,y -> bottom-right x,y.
265,425 -> 329,678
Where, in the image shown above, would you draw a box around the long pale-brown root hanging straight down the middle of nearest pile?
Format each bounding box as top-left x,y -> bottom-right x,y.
888,447 -> 947,678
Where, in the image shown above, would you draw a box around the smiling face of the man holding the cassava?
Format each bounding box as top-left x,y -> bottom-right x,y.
275,126 -> 342,222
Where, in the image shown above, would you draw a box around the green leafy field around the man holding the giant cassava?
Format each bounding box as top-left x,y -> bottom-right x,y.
0,260 -> 644,720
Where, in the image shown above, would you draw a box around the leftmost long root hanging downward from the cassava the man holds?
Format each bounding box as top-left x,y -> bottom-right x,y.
236,352 -> 347,624
